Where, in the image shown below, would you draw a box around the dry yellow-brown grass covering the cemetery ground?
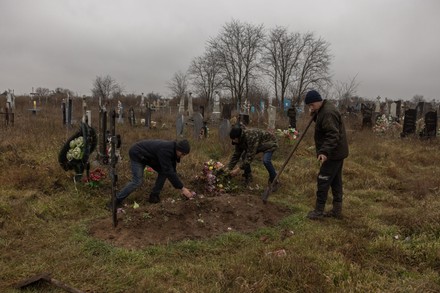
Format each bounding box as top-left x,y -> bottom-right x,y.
0,100 -> 440,292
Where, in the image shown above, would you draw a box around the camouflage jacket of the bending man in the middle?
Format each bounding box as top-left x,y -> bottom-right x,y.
227,128 -> 278,170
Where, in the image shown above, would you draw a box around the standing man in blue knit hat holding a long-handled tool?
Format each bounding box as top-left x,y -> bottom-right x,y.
304,90 -> 348,220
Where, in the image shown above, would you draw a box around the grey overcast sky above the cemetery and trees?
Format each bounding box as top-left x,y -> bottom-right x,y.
0,0 -> 440,101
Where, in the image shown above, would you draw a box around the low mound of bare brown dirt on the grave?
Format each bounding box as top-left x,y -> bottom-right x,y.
90,194 -> 291,248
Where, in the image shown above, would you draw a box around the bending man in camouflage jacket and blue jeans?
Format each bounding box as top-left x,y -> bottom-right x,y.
227,125 -> 278,191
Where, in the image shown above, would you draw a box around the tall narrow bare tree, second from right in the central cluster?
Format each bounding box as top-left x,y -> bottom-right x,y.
263,27 -> 305,107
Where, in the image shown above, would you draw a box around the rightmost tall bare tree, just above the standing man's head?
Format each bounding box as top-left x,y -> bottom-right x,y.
291,33 -> 332,104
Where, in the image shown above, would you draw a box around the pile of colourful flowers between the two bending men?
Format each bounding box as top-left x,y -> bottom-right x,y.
195,159 -> 238,196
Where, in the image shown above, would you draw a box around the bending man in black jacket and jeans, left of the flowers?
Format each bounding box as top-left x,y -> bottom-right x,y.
116,139 -> 193,206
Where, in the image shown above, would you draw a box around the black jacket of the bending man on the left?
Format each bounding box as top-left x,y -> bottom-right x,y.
128,139 -> 183,189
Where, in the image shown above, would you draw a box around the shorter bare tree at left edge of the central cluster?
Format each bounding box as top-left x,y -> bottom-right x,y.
188,48 -> 223,104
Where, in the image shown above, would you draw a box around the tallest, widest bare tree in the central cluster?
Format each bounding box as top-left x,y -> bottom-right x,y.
208,20 -> 264,105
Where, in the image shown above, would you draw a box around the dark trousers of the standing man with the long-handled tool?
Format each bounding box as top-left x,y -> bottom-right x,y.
316,160 -> 344,205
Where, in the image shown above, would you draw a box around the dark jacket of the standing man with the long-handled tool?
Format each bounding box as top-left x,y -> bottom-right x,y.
315,100 -> 348,160
